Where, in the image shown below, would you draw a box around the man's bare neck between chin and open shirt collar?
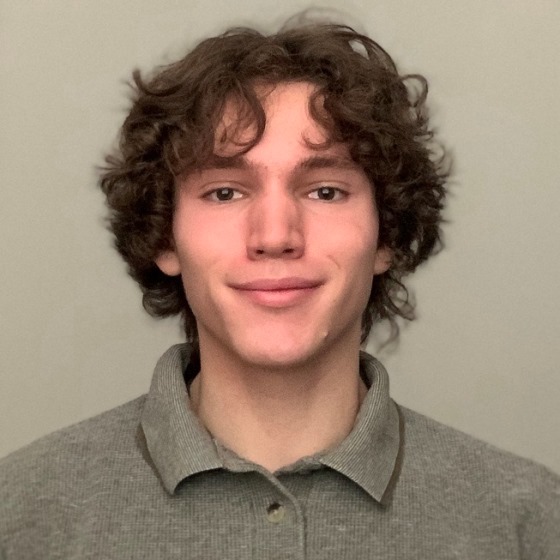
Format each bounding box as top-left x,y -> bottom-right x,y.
190,342 -> 367,472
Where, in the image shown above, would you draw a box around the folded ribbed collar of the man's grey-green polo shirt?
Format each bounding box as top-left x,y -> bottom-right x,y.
141,344 -> 401,502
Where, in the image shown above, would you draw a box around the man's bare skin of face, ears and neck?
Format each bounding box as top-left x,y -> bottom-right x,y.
156,83 -> 390,472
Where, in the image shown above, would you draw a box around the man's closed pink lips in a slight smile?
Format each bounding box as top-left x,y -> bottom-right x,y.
232,277 -> 322,308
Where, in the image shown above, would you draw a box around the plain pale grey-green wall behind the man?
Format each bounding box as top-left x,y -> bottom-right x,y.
0,0 -> 560,471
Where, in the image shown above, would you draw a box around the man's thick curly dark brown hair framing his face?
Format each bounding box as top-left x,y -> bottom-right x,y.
100,24 -> 449,343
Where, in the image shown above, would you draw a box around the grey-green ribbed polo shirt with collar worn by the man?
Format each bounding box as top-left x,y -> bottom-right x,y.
0,345 -> 560,560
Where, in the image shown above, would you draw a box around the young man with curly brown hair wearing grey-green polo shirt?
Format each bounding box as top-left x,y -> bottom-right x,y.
0,19 -> 560,560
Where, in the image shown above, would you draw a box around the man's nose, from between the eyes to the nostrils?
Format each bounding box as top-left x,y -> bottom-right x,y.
247,189 -> 305,260
